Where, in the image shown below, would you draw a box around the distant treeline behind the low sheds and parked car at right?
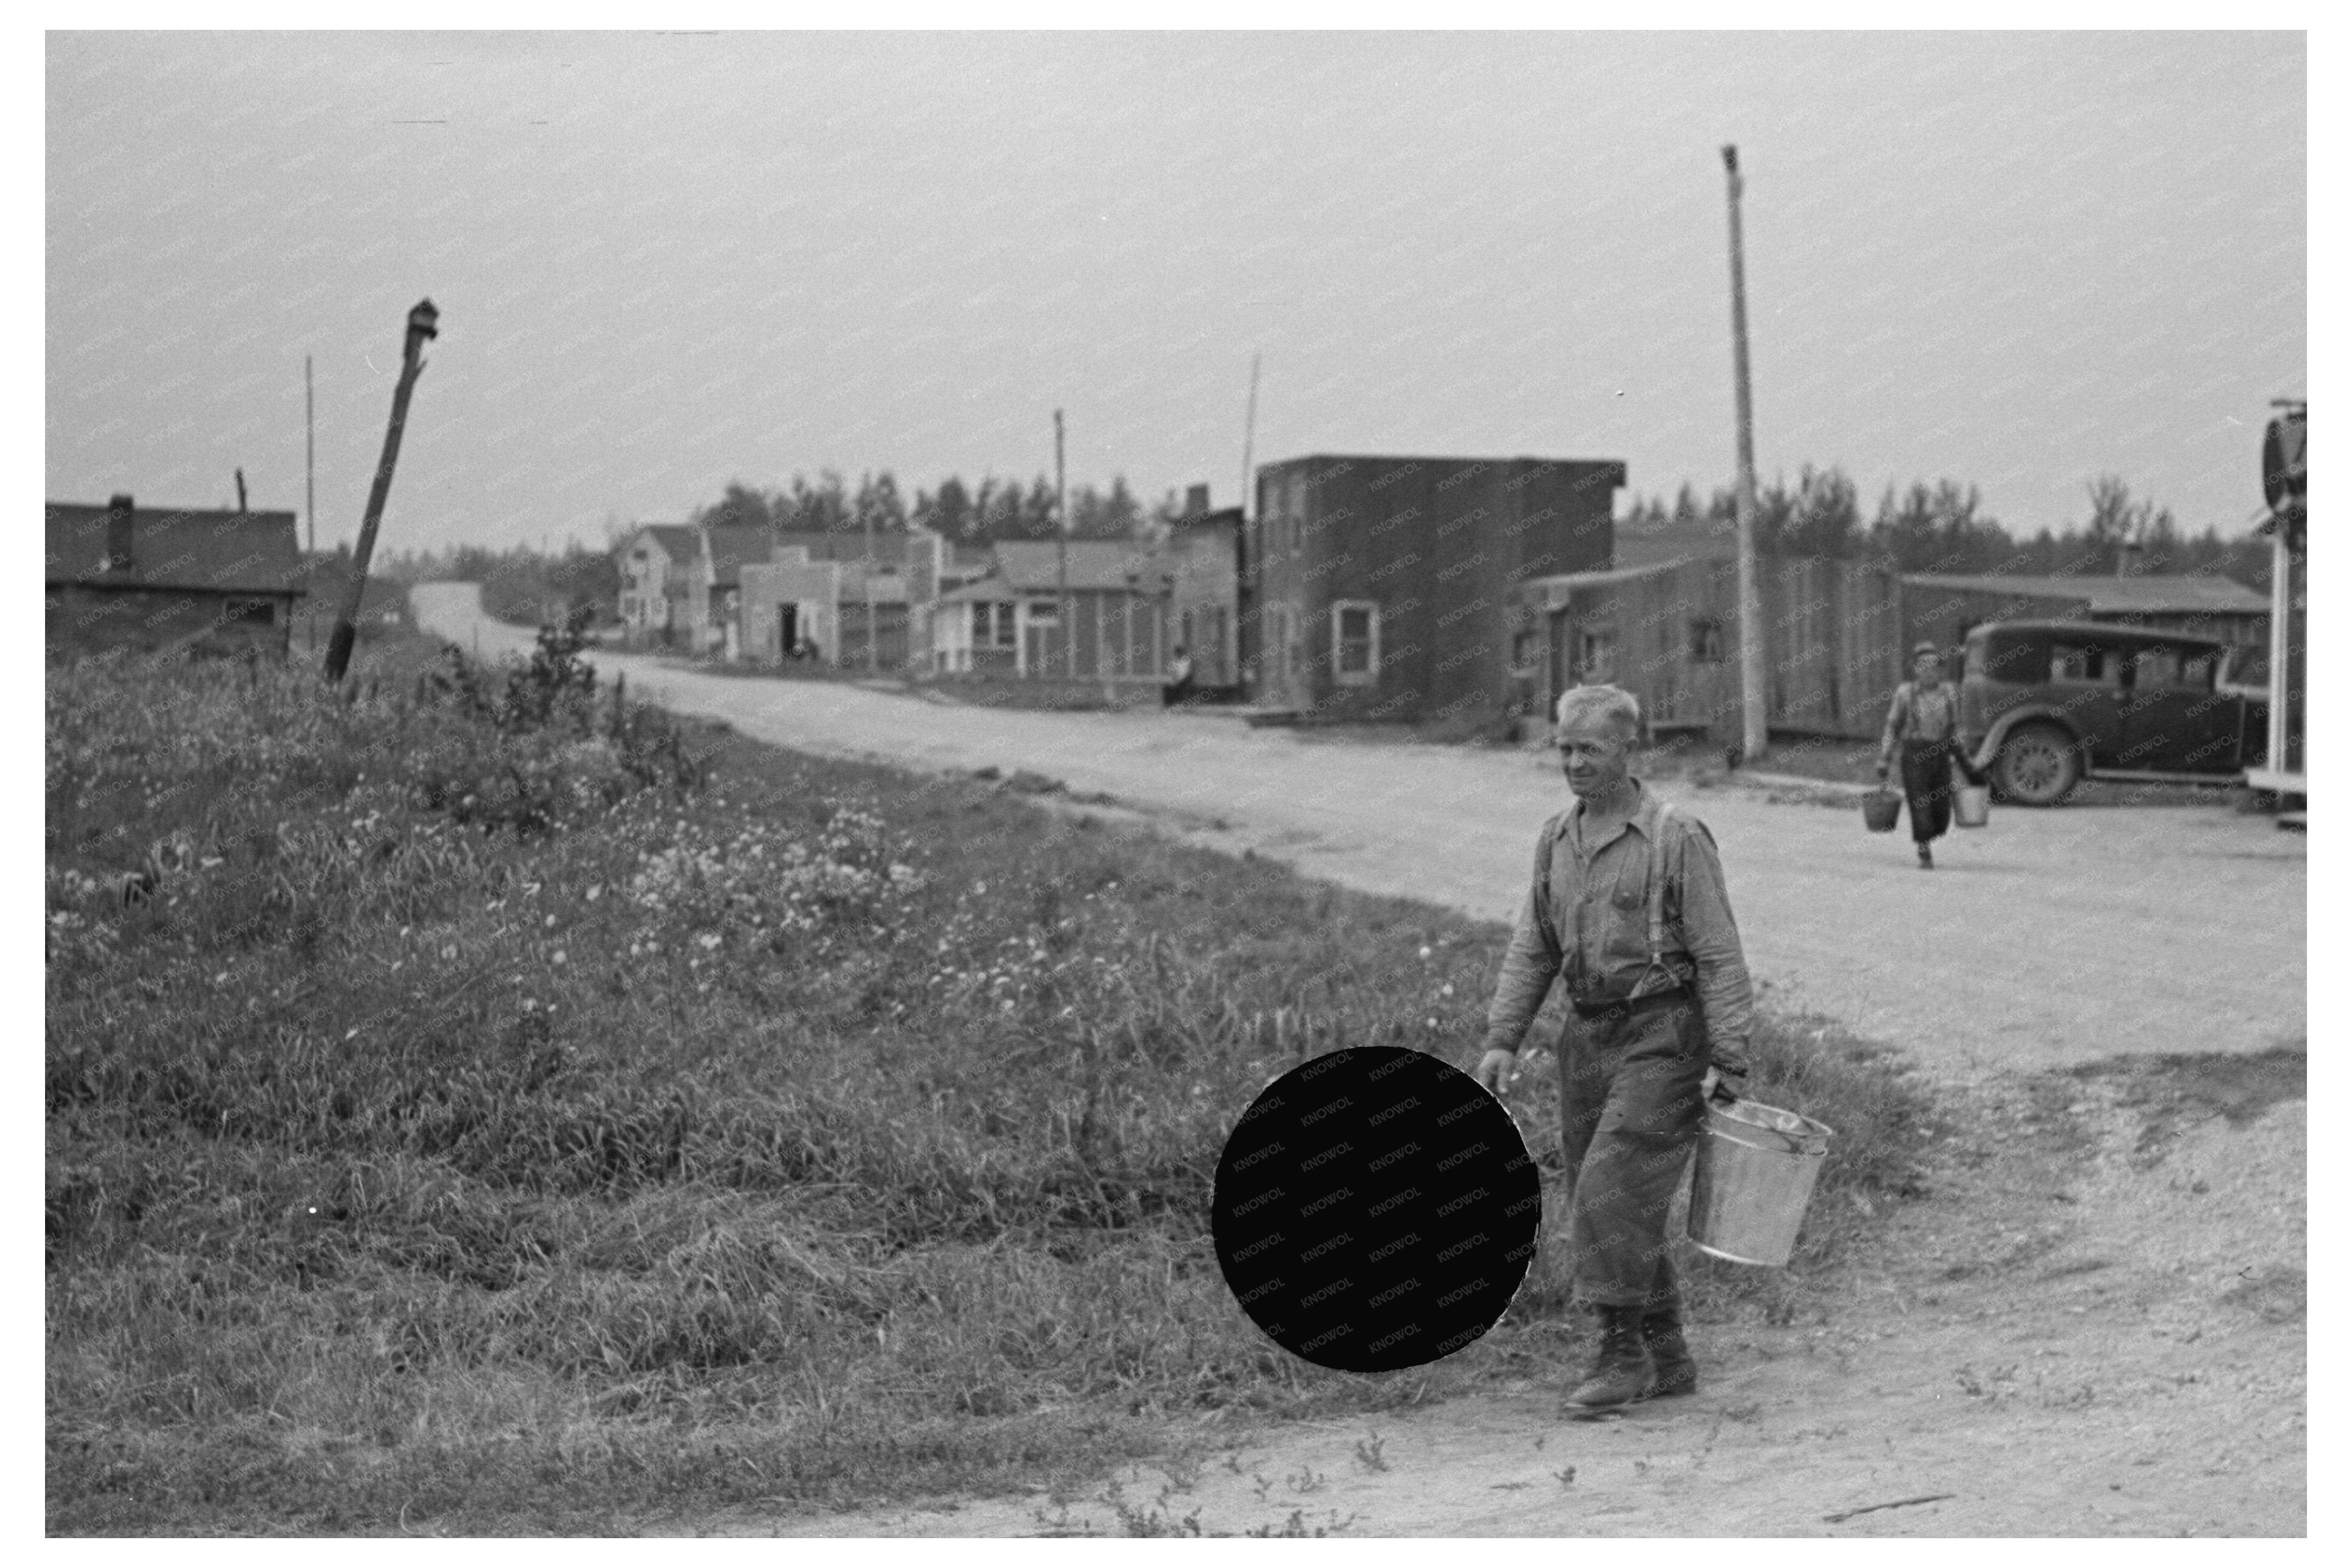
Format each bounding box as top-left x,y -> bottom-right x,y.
1618,463 -> 2270,588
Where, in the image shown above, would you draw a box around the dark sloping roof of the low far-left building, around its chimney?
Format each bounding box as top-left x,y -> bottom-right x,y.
44,501 -> 303,592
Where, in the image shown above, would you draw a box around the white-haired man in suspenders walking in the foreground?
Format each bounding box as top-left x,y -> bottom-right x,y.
1475,687 -> 1750,1415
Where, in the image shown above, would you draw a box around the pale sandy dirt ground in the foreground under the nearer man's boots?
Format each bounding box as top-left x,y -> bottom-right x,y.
691,1079 -> 2305,1538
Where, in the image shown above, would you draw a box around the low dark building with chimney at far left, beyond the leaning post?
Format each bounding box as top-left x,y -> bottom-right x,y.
44,496 -> 303,656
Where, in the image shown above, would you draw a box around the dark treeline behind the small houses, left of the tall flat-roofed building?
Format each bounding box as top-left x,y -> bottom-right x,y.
689,468 -> 1178,545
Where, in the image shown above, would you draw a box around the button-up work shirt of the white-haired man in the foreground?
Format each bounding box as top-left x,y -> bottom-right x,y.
1486,783 -> 1752,1067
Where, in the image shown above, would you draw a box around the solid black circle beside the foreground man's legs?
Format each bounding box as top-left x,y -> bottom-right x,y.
1209,1046 -> 1543,1373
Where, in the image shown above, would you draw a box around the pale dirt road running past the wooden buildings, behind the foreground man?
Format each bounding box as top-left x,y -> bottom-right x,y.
414,586 -> 2305,1082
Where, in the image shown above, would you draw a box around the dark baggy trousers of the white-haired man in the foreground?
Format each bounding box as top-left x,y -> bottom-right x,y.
1559,992 -> 1707,1307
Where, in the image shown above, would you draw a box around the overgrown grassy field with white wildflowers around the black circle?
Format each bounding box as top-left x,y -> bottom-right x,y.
44,639 -> 1927,1533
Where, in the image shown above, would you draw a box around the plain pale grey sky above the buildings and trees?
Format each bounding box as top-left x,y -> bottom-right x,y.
44,33 -> 2308,553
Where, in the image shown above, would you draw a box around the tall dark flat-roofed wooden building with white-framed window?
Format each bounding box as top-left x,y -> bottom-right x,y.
1239,456 -> 1625,719
